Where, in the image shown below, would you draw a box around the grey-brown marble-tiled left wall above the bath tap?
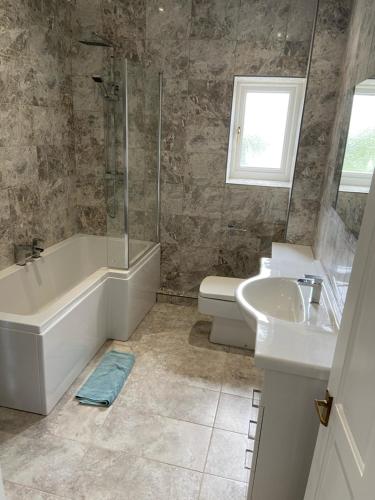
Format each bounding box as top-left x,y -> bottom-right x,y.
0,0 -> 76,268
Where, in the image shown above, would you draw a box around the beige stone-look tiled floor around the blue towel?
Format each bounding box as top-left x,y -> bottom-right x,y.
0,304 -> 262,500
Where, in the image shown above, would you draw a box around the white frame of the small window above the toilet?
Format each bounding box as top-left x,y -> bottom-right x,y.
226,76 -> 306,187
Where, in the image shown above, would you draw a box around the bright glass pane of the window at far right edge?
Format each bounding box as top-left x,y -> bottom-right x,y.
343,94 -> 375,174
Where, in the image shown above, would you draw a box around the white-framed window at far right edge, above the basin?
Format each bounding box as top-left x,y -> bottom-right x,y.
340,80 -> 375,193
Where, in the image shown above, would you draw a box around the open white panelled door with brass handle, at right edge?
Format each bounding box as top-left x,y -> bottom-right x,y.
305,185 -> 375,500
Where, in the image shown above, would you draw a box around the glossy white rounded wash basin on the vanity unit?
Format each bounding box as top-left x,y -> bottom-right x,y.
235,272 -> 338,380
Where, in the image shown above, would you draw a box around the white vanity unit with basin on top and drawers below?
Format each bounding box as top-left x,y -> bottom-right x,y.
236,244 -> 337,500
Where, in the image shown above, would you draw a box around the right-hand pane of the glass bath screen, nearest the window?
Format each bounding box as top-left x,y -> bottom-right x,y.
127,62 -> 160,265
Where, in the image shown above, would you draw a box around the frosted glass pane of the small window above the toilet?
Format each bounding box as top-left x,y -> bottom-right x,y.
240,92 -> 289,169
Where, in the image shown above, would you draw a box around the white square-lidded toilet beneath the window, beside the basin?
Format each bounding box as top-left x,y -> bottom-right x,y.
198,276 -> 255,349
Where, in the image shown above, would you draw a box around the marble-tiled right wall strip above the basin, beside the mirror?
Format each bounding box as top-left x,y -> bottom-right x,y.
314,0 -> 375,307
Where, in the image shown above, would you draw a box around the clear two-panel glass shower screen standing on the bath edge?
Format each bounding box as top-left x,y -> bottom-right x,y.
103,58 -> 160,269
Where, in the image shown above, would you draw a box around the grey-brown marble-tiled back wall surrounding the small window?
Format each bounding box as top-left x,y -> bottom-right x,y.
73,0 -> 315,295
